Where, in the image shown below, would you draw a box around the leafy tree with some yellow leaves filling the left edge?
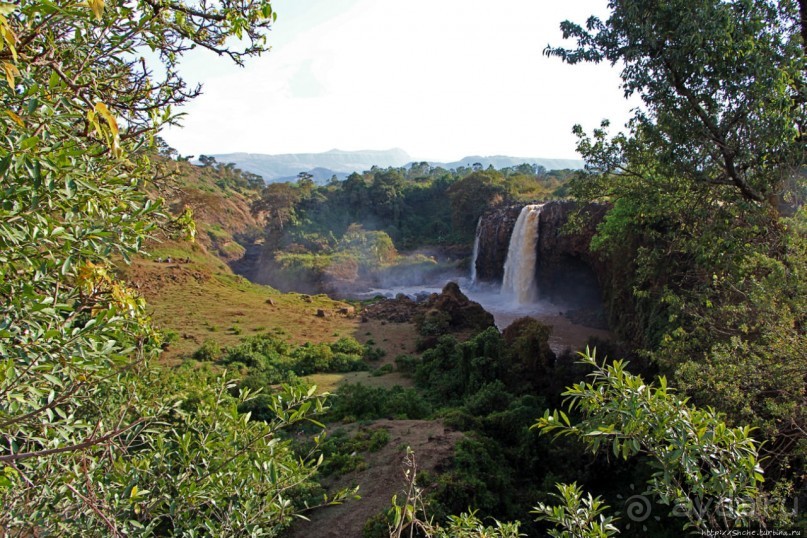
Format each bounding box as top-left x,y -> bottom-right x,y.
0,0 -> 348,536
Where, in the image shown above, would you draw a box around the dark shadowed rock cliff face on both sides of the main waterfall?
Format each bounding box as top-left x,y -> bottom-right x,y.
476,201 -> 607,303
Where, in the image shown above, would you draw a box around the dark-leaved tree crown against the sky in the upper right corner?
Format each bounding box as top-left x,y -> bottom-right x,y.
546,0 -> 807,209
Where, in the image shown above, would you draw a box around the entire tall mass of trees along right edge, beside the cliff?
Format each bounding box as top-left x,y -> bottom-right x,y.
546,0 -> 807,500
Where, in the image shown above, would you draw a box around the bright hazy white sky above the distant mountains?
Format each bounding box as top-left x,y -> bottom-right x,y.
164,0 -> 630,161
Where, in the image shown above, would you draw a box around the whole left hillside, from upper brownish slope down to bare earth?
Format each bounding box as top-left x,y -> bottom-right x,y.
121,157 -> 415,390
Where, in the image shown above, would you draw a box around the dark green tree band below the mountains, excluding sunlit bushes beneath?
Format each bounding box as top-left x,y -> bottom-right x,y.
255,163 -> 570,247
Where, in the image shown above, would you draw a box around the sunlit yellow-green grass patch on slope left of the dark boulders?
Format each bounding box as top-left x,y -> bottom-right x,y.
122,245 -> 359,364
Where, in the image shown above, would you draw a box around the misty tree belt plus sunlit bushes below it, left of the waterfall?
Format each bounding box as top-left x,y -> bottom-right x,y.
253,163 -> 572,292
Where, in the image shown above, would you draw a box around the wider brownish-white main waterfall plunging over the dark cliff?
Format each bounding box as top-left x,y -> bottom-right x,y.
501,204 -> 543,304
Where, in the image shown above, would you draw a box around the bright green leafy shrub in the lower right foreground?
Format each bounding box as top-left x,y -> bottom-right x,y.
535,349 -> 765,530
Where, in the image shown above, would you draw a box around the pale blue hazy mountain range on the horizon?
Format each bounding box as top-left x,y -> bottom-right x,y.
208,148 -> 583,183
